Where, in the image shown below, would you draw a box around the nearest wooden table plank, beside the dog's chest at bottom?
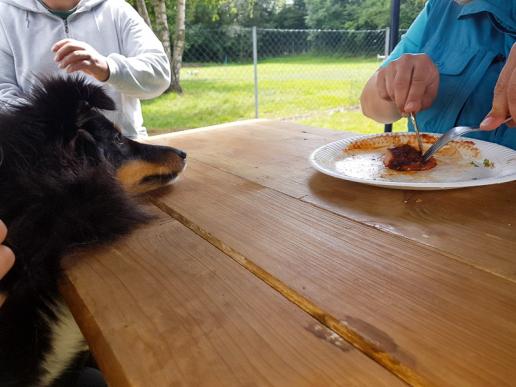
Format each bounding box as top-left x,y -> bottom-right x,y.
62,210 -> 403,387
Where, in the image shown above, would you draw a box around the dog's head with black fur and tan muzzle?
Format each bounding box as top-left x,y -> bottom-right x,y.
0,77 -> 186,194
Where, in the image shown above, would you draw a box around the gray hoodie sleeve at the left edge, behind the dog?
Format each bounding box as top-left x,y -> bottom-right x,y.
0,18 -> 22,106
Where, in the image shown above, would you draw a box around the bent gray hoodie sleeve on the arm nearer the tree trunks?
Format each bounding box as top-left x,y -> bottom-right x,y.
106,1 -> 170,99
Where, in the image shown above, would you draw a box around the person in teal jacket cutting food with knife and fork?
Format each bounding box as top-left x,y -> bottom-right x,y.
360,0 -> 516,149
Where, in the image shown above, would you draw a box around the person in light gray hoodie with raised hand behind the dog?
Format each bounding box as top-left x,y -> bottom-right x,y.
0,0 -> 170,138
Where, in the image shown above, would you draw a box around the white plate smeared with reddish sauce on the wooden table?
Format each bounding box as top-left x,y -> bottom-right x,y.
310,133 -> 516,190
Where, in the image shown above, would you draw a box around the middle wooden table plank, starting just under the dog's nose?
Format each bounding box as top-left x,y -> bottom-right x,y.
150,161 -> 516,386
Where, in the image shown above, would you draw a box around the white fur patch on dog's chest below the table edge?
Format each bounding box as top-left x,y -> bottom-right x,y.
40,301 -> 88,386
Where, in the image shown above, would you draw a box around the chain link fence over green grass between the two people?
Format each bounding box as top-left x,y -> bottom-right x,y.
144,27 -> 406,133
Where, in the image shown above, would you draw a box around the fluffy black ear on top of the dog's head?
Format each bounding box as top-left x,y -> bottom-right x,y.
27,76 -> 115,143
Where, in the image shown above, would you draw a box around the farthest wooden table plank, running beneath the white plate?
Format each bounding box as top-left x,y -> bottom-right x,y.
151,121 -> 516,281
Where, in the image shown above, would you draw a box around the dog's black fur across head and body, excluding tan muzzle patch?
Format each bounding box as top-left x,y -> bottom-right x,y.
0,78 -> 186,387
